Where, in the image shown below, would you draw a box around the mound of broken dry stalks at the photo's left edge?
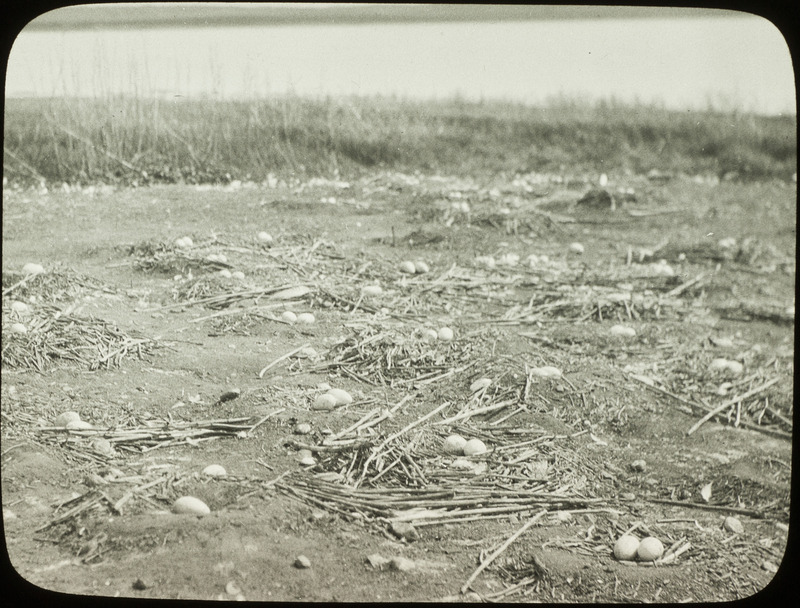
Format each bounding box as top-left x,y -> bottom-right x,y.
2,305 -> 155,372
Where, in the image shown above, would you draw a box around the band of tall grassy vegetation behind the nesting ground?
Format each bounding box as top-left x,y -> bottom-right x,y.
3,97 -> 797,184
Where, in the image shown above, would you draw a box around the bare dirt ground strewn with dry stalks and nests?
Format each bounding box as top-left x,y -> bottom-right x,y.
2,167 -> 796,602
